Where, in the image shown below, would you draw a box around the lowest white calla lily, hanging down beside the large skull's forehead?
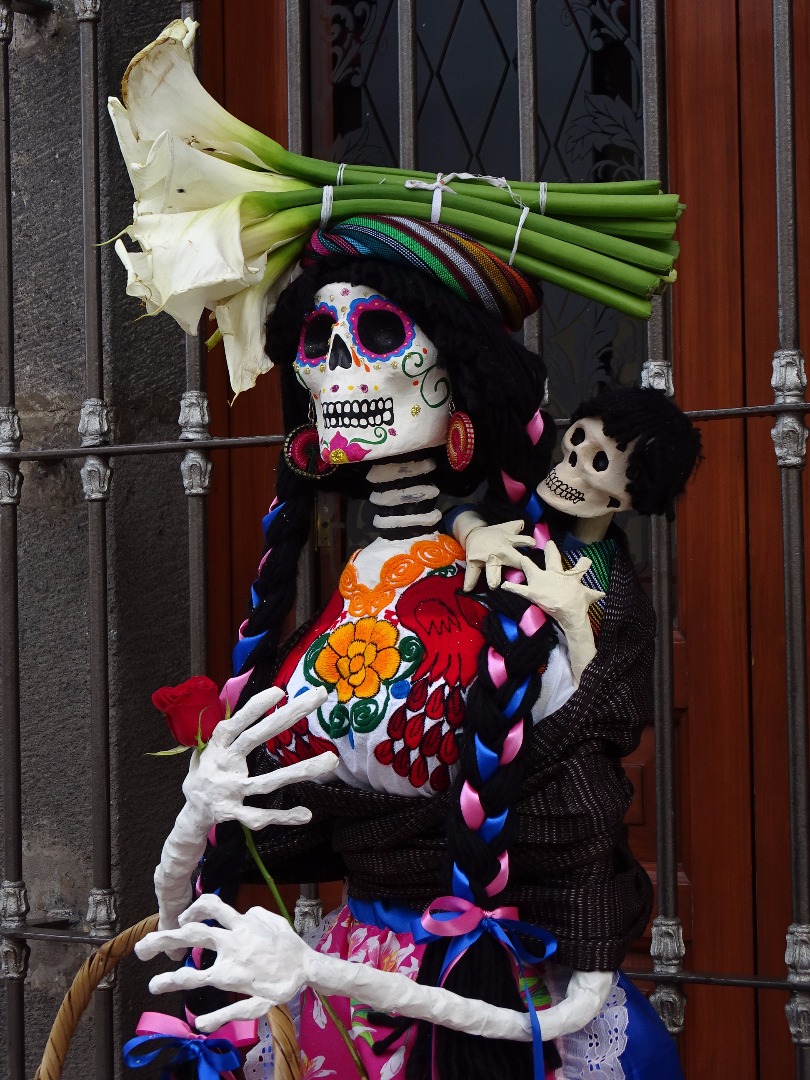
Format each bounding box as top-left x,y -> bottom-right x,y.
215,240 -> 303,394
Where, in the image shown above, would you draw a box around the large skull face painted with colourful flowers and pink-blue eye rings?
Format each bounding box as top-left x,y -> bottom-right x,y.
294,282 -> 450,464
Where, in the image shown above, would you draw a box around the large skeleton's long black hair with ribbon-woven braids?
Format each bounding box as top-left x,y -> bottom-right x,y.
202,257 -> 556,1080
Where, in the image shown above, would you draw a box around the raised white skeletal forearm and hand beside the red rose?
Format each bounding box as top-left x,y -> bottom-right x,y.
154,687 -> 338,937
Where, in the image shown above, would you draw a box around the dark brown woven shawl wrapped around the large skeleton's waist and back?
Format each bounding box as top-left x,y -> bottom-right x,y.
245,543 -> 654,971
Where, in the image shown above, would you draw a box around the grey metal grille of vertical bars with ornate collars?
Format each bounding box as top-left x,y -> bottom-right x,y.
0,0 -> 810,1080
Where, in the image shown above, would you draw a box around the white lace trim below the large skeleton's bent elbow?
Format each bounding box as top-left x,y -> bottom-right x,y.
541,964 -> 627,1080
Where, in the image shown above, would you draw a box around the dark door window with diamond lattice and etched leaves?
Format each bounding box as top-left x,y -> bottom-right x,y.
312,0 -> 644,415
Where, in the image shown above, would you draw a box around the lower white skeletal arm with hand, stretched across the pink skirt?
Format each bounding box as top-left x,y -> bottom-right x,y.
135,894 -> 612,1042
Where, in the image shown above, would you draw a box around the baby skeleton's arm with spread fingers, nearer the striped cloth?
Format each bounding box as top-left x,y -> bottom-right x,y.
501,540 -> 605,684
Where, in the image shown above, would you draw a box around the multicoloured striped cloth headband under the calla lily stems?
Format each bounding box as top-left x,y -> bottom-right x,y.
301,215 -> 542,330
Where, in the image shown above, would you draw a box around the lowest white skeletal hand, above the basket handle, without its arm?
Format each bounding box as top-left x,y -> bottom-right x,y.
135,893 -> 315,1031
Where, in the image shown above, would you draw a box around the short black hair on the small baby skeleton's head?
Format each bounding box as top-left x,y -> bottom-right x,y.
571,387 -> 701,522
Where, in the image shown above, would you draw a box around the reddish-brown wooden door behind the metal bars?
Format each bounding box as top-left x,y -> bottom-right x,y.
202,0 -> 810,1080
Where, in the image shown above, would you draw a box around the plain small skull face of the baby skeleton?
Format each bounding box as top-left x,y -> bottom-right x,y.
537,416 -> 633,517
